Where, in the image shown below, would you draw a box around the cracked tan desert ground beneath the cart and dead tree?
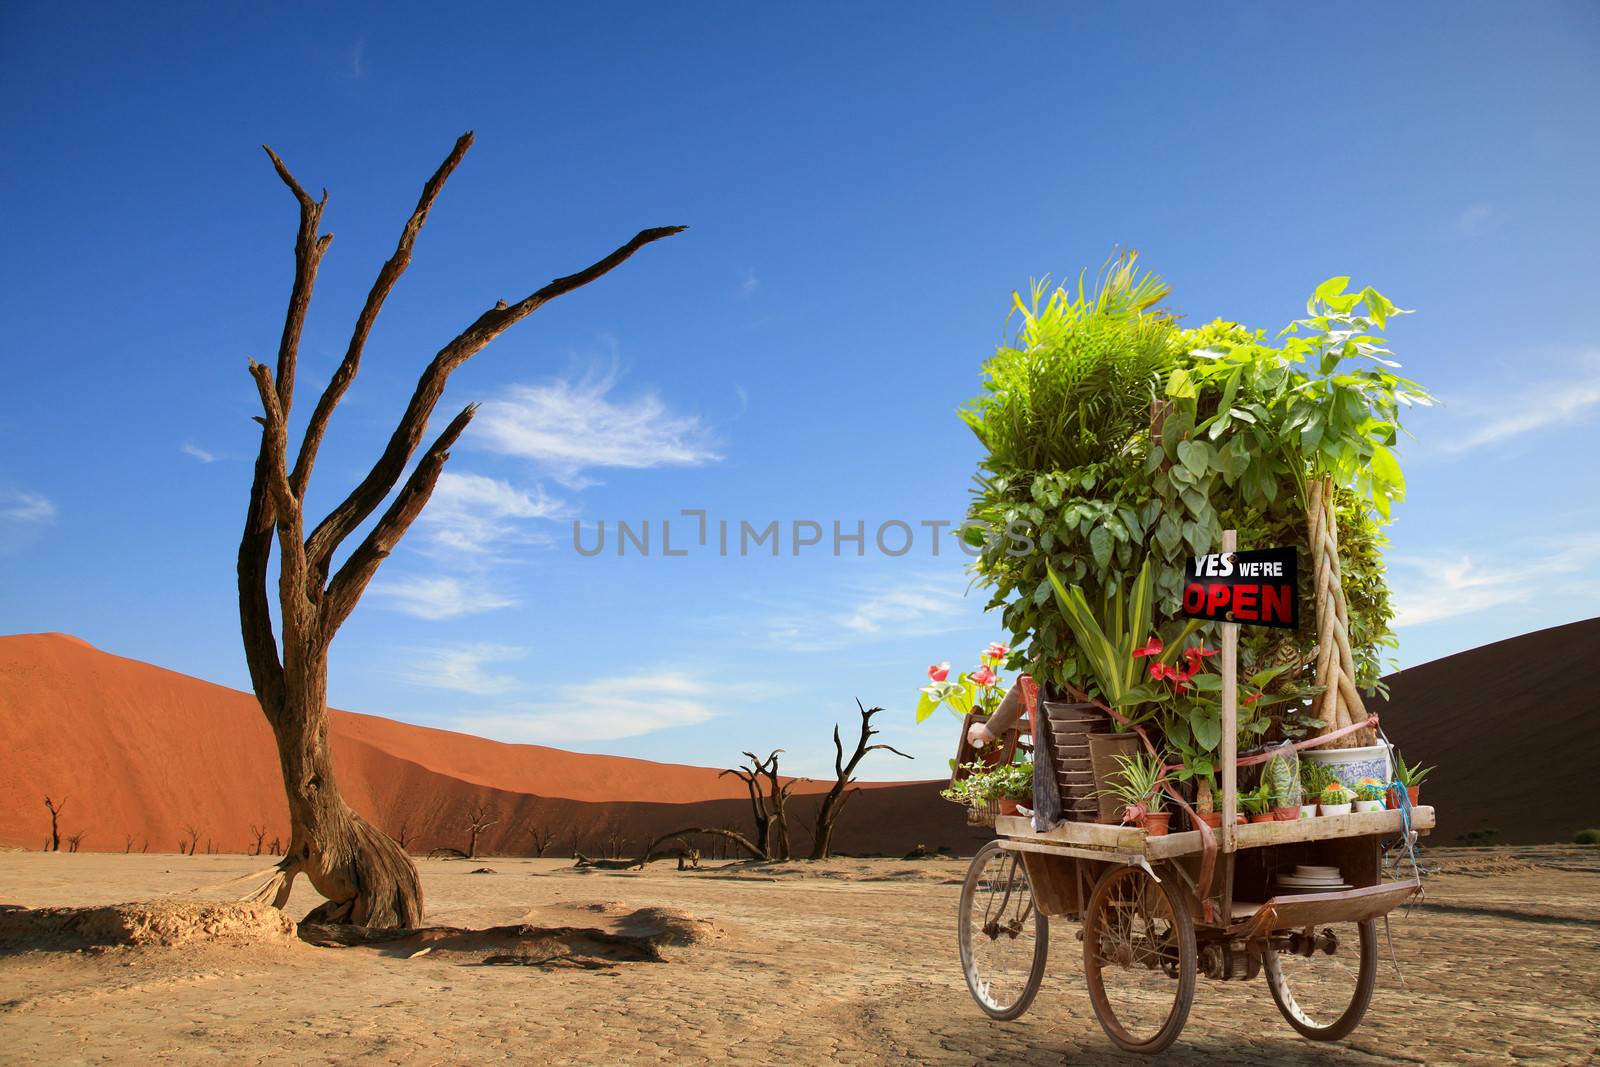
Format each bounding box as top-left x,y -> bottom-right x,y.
0,848 -> 1600,1064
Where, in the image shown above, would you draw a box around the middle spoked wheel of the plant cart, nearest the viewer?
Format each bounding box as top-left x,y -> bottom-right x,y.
1083,865 -> 1195,1053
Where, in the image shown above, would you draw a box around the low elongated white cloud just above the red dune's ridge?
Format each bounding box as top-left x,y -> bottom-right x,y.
453,670 -> 726,745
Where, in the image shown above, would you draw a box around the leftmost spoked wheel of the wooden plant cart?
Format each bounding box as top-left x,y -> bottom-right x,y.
957,841 -> 1050,1019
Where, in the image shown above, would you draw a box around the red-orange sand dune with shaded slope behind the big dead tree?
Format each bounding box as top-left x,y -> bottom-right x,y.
0,633 -> 978,854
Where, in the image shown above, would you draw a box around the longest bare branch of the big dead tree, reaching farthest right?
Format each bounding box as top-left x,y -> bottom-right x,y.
306,226 -> 685,571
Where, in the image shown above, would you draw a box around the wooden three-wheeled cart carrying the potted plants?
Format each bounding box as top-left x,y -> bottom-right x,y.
958,755 -> 1434,1053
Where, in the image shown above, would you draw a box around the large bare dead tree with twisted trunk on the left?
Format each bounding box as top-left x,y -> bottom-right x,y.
238,133 -> 683,926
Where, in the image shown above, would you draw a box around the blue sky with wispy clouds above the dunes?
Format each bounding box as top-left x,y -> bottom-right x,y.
0,3 -> 1600,777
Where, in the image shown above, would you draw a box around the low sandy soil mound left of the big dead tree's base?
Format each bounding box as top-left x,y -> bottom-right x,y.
0,901 -> 294,952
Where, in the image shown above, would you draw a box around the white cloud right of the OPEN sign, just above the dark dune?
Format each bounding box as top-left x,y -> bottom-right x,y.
1390,533 -> 1600,629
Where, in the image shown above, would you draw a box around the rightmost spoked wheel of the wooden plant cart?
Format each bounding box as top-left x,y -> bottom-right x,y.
1261,918 -> 1378,1041
